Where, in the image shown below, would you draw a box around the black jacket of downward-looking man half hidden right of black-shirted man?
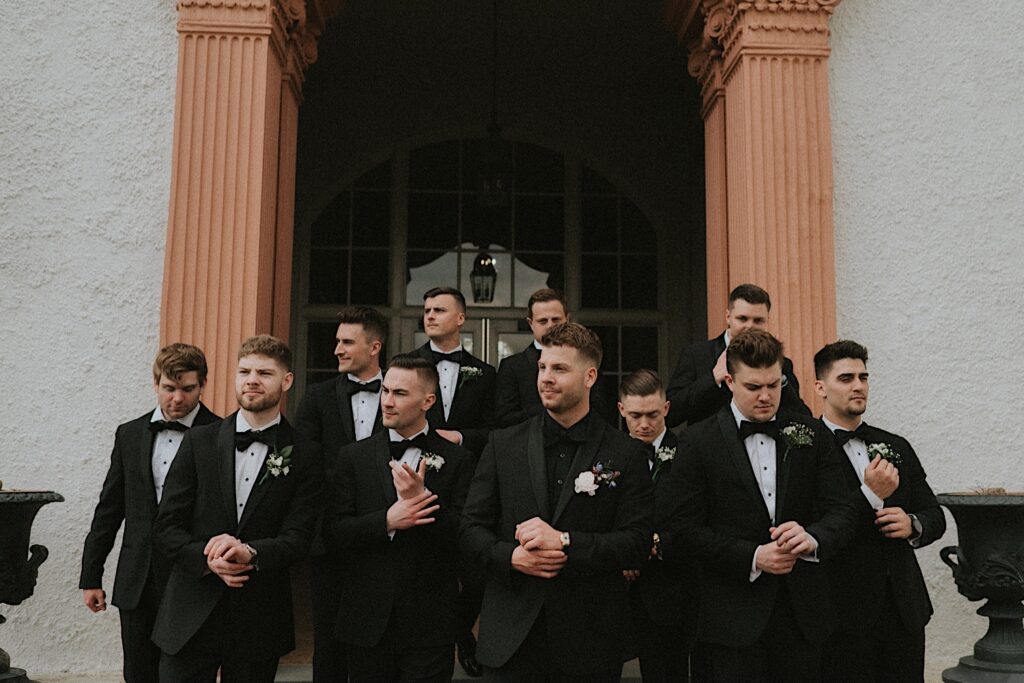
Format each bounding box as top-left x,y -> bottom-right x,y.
630,430 -> 700,632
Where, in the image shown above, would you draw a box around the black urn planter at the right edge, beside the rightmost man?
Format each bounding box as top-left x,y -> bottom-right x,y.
938,489 -> 1024,683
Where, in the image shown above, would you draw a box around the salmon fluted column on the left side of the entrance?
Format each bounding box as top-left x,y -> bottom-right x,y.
160,0 -> 318,414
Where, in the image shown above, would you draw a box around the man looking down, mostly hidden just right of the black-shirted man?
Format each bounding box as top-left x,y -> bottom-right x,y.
618,370 -> 700,683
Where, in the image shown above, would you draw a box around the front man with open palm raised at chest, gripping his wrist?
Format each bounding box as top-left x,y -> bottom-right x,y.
325,355 -> 473,683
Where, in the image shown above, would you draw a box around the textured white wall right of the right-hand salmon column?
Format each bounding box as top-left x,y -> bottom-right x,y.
830,0 -> 1024,680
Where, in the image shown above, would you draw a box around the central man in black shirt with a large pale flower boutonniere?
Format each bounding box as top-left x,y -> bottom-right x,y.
461,323 -> 653,682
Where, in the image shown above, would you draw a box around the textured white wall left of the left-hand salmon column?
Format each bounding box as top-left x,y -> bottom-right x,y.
0,0 -> 177,673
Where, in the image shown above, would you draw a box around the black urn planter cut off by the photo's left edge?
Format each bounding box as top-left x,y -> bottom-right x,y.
0,484 -> 63,683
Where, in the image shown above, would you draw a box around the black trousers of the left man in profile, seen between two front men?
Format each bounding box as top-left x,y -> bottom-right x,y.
309,553 -> 348,683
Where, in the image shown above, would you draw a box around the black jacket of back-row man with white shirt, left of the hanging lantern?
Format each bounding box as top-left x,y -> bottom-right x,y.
414,342 -> 496,456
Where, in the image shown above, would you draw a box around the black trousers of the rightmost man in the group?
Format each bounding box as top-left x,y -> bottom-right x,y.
821,585 -> 925,683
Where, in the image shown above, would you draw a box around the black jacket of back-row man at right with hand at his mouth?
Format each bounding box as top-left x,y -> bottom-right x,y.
665,332 -> 811,427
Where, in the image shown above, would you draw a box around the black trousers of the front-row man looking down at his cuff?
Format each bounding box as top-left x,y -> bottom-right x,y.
690,590 -> 822,683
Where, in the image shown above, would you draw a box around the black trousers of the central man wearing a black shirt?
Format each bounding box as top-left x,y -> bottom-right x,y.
483,609 -> 623,683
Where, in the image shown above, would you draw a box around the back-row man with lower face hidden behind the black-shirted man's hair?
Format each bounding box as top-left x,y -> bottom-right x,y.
495,289 -> 569,427
